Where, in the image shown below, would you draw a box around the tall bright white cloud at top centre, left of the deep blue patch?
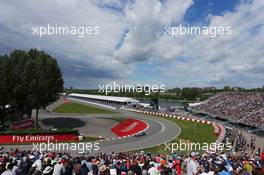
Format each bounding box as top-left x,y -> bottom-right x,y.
115,0 -> 192,63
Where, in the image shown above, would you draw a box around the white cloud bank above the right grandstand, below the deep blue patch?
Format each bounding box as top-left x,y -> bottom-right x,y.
158,1 -> 264,87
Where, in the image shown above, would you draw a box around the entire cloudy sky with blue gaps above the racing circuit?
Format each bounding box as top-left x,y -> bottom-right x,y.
0,0 -> 264,88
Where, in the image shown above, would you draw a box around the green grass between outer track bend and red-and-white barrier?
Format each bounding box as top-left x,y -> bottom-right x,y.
129,118 -> 217,154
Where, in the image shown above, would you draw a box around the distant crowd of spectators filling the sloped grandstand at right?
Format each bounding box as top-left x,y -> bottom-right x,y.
194,92 -> 264,127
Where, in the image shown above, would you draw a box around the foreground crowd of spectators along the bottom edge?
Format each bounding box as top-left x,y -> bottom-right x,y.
0,142 -> 264,175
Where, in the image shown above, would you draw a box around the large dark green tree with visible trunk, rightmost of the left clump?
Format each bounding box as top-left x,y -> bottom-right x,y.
24,49 -> 64,126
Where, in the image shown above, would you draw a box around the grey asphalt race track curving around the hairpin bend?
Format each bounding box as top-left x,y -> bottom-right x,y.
2,99 -> 181,155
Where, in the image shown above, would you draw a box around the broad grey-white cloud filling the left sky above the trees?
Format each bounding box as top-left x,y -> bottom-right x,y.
0,0 -> 129,82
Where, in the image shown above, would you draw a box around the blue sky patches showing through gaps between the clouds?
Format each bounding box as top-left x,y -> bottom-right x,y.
126,0 -> 248,86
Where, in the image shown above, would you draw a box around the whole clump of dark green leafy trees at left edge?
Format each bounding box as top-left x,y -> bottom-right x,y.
0,49 -> 64,128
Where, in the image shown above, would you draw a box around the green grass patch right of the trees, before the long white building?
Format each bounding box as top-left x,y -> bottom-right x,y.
53,102 -> 116,114
